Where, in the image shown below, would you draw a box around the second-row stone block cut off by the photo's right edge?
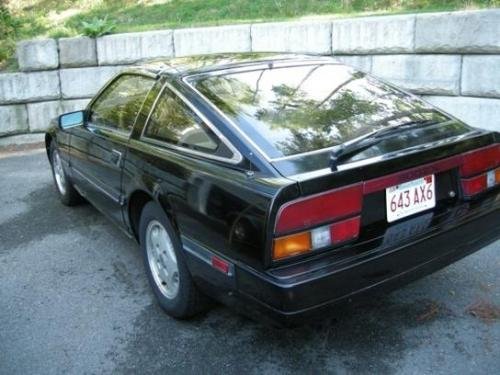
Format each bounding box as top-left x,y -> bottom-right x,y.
462,55 -> 500,98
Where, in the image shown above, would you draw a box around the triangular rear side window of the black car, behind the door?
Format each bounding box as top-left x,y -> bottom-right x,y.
144,88 -> 220,153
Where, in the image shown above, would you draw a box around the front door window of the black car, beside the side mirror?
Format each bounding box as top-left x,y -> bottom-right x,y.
90,74 -> 155,133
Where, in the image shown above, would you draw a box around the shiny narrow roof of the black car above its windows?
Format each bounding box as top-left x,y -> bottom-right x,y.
130,52 -> 331,76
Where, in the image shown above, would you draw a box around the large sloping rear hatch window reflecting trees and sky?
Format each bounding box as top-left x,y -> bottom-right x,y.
191,63 -> 446,159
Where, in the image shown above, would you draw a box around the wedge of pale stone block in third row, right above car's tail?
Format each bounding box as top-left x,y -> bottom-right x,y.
423,96 -> 500,132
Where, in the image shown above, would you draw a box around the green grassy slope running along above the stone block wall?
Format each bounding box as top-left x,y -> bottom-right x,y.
0,0 -> 500,67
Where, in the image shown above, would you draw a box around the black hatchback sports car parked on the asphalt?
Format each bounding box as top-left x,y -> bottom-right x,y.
46,54 -> 500,323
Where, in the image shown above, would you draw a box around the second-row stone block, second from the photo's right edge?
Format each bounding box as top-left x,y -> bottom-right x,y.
372,55 -> 461,95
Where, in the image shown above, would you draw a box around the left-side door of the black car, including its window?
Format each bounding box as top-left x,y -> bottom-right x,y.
85,73 -> 155,223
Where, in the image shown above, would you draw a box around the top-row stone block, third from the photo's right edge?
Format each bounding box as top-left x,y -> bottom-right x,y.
252,21 -> 332,54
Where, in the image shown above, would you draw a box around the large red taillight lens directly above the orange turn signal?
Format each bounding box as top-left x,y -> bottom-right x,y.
275,184 -> 363,234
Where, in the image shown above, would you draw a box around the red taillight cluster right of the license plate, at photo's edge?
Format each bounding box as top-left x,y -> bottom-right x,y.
460,144 -> 500,198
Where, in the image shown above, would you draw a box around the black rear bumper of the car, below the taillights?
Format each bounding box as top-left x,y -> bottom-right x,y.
185,195 -> 500,324
